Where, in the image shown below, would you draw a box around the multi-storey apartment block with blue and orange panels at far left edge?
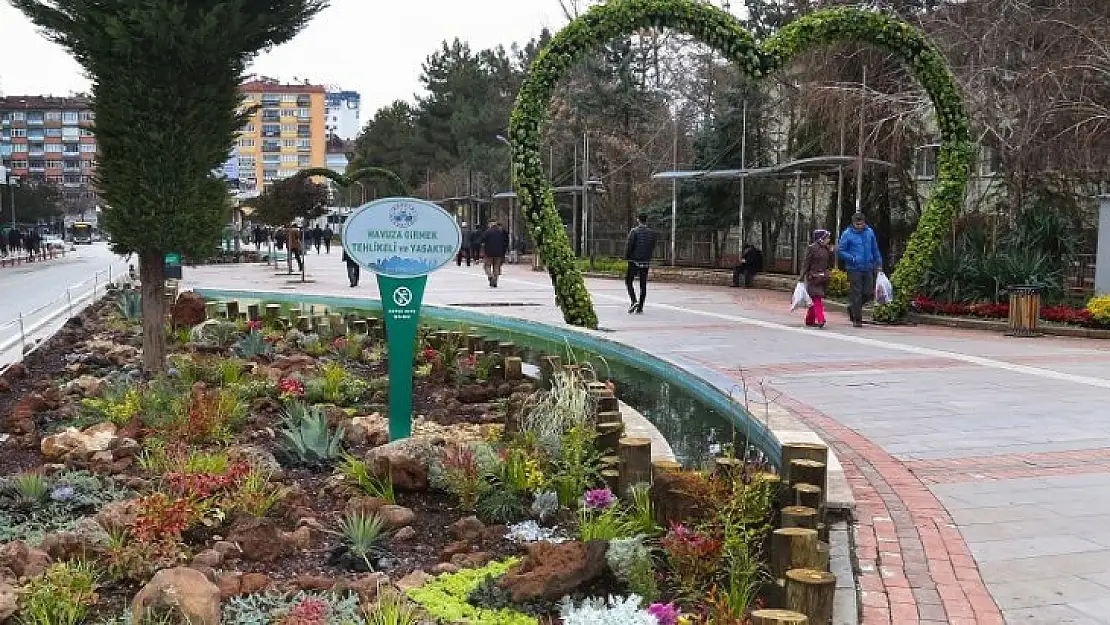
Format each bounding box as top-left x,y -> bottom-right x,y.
0,95 -> 99,211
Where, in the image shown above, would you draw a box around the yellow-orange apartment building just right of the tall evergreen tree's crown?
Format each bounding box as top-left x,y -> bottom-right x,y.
235,78 -> 327,194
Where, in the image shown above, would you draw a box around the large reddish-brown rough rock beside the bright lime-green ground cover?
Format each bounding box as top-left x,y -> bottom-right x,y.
497,541 -> 608,603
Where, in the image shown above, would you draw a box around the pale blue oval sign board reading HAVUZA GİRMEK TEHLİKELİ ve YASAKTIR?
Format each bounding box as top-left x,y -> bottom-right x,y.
342,198 -> 463,278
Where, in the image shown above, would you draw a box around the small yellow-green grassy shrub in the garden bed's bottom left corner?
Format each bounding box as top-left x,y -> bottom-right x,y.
20,562 -> 97,625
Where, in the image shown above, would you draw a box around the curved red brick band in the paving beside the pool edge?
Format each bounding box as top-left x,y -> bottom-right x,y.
777,395 -> 1003,625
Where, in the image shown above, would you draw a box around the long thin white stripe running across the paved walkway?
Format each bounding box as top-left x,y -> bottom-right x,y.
509,279 -> 1110,389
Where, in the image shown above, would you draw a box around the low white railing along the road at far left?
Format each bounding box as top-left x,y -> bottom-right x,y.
0,261 -> 128,373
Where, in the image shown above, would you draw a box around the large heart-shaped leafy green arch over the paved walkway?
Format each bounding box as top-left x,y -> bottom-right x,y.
509,0 -> 971,327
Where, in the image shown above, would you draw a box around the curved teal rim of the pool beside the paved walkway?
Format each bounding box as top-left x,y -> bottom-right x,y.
195,289 -> 781,467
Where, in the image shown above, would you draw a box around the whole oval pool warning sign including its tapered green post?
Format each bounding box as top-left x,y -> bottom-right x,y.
342,198 -> 463,441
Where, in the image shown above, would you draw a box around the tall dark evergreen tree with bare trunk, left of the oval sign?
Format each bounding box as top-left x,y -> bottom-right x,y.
12,0 -> 326,373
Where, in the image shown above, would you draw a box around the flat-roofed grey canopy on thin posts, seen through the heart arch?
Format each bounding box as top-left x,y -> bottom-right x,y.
652,155 -> 896,272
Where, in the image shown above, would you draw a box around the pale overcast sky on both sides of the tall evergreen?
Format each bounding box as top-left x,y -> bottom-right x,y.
0,0 -> 565,116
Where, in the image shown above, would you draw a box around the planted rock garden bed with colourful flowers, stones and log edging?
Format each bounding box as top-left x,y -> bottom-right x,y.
0,289 -> 835,625
